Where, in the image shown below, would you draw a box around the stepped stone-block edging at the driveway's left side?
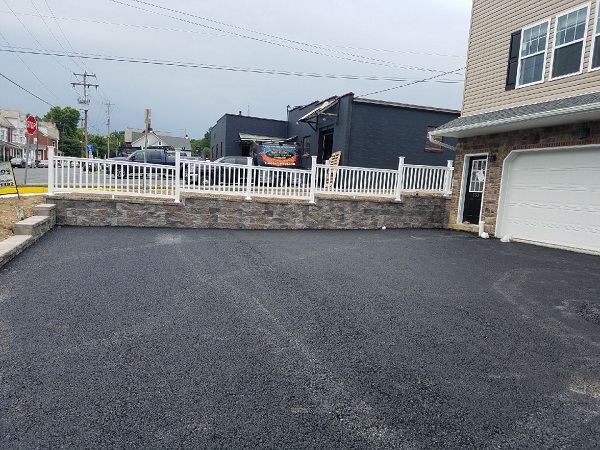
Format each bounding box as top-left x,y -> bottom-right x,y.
0,204 -> 56,267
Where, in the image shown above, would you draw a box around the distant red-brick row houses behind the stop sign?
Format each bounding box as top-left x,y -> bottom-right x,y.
0,109 -> 60,161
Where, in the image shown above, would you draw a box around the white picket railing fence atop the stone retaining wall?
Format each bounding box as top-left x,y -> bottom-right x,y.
48,152 -> 454,202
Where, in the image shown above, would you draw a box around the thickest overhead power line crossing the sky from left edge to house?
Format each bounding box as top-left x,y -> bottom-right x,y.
0,46 -> 463,84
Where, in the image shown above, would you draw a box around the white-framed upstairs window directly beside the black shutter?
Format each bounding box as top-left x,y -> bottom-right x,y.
518,21 -> 549,86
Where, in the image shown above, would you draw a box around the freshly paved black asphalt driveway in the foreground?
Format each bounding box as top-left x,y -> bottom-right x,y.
0,228 -> 600,449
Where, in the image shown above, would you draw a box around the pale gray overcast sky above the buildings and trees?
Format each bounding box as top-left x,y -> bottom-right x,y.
0,0 -> 471,138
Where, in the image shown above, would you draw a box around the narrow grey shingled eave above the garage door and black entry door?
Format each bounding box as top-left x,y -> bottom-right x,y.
431,103 -> 600,138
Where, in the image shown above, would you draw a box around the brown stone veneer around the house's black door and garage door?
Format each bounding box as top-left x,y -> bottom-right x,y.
448,122 -> 600,235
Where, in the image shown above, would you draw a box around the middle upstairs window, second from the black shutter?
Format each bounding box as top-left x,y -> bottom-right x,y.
552,6 -> 588,78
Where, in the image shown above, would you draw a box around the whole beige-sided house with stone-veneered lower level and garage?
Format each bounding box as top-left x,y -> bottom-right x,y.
430,0 -> 600,253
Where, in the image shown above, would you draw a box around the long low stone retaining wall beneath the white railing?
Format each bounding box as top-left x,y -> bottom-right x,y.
47,195 -> 450,229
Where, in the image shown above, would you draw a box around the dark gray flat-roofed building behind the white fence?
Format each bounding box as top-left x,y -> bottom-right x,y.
211,93 -> 460,169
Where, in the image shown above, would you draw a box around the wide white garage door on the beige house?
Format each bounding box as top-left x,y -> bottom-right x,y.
497,147 -> 600,252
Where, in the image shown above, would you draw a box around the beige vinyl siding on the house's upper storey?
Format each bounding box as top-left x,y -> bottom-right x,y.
463,0 -> 600,115
